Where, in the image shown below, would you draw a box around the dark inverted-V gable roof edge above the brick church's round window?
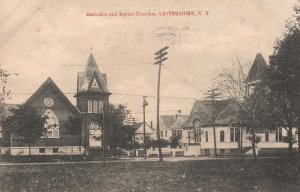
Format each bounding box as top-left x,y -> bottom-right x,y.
24,77 -> 80,116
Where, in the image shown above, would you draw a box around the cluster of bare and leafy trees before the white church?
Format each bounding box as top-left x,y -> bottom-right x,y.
218,6 -> 300,158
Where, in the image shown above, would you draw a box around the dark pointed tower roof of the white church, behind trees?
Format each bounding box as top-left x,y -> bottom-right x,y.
245,53 -> 268,83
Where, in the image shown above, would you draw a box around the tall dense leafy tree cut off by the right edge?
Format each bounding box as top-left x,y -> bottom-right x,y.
266,6 -> 300,155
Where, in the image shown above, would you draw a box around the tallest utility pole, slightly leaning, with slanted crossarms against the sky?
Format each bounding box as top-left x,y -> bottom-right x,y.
154,46 -> 169,161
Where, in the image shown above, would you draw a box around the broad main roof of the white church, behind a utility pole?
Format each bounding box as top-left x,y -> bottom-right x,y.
187,99 -> 236,126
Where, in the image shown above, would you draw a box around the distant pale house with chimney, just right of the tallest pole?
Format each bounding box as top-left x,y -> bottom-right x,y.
160,111 -> 188,141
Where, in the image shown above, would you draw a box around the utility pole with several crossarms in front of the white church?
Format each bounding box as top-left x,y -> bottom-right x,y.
205,88 -> 222,157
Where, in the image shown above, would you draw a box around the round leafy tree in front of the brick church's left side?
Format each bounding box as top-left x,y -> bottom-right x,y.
5,105 -> 48,161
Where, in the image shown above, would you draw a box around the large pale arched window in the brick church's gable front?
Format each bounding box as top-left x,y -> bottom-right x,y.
43,109 -> 59,138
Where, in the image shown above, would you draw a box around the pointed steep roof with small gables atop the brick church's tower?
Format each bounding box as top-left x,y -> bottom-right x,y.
77,53 -> 110,94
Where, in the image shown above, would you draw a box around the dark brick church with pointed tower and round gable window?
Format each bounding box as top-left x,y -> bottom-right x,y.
0,54 -> 111,155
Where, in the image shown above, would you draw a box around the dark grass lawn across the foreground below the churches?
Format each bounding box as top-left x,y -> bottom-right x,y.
0,159 -> 300,192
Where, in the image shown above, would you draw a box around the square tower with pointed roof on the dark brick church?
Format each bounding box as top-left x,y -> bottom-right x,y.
75,53 -> 111,147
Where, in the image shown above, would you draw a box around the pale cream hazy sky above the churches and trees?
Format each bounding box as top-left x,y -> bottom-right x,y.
0,0 -> 299,121
